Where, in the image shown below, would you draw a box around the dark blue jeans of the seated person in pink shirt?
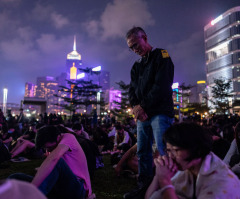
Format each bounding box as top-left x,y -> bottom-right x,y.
9,159 -> 86,199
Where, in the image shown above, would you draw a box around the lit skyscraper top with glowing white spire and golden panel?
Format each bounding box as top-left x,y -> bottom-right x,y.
66,36 -> 82,79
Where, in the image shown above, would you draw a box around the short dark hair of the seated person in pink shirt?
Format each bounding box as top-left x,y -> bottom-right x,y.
35,125 -> 61,149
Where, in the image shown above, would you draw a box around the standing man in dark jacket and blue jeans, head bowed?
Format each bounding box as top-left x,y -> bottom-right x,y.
124,27 -> 174,198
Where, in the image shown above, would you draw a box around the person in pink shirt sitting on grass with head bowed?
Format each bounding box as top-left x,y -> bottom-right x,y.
10,126 -> 94,199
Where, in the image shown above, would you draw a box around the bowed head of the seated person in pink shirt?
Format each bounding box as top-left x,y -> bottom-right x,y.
35,125 -> 61,152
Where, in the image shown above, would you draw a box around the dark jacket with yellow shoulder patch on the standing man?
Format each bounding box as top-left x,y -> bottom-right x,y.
129,49 -> 174,117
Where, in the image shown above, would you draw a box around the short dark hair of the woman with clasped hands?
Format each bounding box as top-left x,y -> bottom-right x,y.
163,122 -> 213,161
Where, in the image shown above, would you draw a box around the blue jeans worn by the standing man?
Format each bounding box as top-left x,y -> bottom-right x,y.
137,115 -> 173,177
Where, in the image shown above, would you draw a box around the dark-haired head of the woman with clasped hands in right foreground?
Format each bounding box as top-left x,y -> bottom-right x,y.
163,123 -> 213,170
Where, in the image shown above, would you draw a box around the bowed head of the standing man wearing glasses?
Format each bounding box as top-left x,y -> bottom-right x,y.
126,27 -> 152,57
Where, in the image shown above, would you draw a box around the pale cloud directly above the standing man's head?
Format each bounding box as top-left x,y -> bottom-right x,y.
84,0 -> 155,40
